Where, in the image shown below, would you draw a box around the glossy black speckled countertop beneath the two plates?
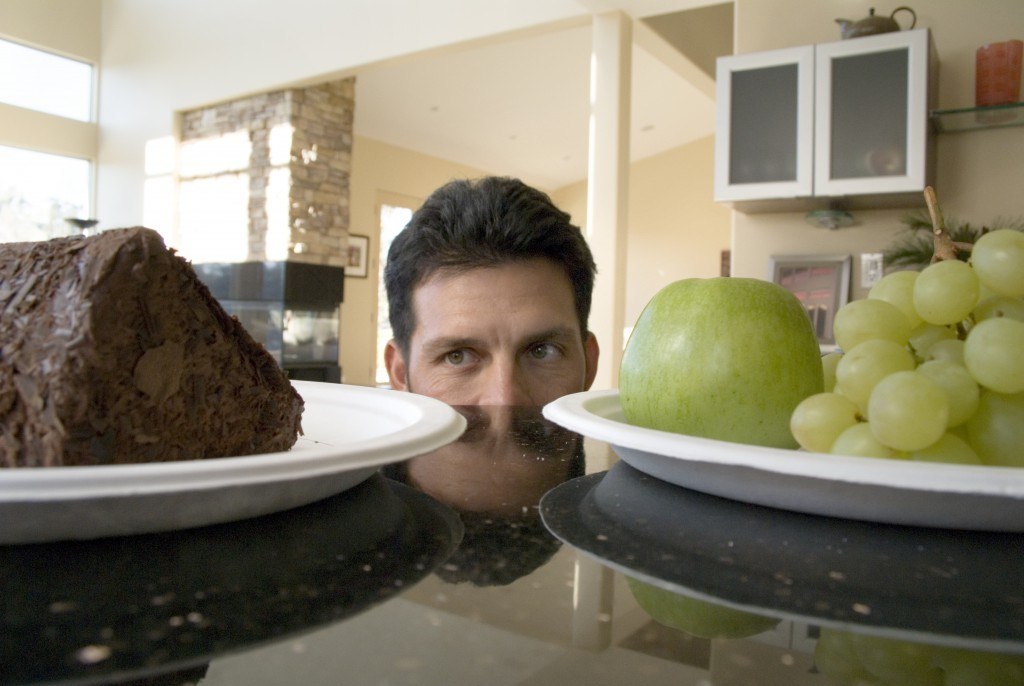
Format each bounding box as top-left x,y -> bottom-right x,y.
0,408 -> 1024,686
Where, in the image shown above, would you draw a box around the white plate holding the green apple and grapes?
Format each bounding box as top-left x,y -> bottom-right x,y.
544,390 -> 1024,531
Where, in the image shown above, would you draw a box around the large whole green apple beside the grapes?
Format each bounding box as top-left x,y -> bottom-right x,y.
618,276 -> 823,447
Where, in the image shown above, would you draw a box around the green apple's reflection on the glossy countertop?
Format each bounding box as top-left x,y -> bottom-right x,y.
626,576 -> 779,638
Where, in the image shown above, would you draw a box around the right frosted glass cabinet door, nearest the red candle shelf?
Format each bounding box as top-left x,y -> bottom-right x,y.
814,29 -> 929,196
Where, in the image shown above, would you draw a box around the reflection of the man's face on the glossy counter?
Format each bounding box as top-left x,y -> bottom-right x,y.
407,406 -> 580,517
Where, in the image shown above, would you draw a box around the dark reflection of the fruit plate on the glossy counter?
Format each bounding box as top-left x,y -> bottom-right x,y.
541,462 -> 1024,653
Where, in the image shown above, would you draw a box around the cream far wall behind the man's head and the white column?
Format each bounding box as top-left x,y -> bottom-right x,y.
341,130 -> 729,385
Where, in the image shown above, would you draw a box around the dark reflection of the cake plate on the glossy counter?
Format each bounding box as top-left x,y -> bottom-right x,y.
0,475 -> 462,684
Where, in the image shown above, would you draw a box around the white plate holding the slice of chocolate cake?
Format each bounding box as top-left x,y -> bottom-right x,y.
0,381 -> 466,544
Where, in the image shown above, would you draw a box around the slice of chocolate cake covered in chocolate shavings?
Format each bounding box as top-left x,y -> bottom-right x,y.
0,228 -> 303,467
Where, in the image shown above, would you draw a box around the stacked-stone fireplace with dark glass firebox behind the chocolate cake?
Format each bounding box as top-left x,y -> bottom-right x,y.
175,79 -> 355,382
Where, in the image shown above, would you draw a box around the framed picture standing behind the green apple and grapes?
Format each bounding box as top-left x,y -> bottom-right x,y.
771,255 -> 853,350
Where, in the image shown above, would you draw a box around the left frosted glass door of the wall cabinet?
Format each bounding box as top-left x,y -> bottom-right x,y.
715,46 -> 814,201
